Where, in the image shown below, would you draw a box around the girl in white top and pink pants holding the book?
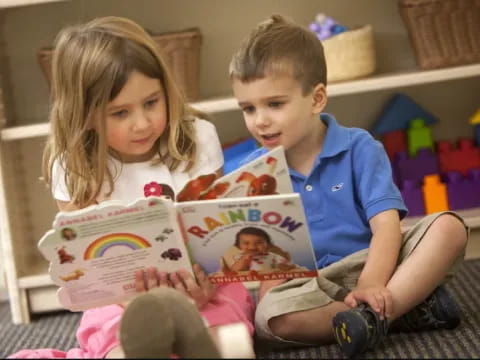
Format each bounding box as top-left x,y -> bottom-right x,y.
8,17 -> 253,358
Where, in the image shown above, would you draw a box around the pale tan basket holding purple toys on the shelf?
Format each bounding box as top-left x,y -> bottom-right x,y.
322,25 -> 376,83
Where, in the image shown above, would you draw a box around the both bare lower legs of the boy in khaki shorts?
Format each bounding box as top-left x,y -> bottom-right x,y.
269,215 -> 467,344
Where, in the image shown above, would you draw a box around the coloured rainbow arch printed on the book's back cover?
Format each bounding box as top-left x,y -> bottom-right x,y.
83,233 -> 151,260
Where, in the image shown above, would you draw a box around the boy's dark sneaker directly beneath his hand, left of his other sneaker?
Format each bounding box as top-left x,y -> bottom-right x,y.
333,304 -> 388,357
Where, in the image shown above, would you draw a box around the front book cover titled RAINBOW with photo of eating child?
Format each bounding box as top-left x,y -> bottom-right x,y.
176,194 -> 317,283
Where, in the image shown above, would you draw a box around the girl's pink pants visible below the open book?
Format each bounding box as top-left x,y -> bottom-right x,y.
9,283 -> 255,359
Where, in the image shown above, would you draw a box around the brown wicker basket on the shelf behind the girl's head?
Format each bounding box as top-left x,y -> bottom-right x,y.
37,28 -> 202,101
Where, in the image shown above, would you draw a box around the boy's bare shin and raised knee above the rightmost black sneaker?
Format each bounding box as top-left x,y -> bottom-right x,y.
387,214 -> 467,321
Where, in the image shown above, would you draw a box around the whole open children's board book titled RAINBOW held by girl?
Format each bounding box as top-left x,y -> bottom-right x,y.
38,148 -> 317,311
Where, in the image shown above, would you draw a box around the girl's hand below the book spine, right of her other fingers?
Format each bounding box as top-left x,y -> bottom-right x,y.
170,264 -> 217,309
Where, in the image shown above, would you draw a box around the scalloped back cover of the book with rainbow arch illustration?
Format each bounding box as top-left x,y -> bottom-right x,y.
39,197 -> 193,311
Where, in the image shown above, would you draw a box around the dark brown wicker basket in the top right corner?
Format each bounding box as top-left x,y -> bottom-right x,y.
399,0 -> 480,69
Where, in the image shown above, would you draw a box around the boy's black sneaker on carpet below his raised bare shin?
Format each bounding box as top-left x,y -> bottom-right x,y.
392,285 -> 460,332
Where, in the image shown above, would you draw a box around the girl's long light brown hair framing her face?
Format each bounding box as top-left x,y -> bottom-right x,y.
42,17 -> 205,207
